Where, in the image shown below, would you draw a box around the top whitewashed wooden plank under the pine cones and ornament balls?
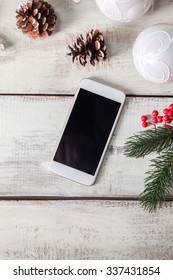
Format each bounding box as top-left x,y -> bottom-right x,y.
0,0 -> 172,95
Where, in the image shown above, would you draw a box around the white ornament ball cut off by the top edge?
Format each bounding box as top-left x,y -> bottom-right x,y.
96,0 -> 154,22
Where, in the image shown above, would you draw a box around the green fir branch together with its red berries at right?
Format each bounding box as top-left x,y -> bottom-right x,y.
124,103 -> 173,212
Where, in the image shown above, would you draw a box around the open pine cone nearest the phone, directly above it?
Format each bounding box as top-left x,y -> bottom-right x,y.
68,30 -> 107,66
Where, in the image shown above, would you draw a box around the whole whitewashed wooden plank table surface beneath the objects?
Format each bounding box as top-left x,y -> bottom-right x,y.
0,0 -> 173,259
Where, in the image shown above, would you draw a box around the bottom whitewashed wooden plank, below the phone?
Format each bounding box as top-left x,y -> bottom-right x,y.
0,201 -> 173,260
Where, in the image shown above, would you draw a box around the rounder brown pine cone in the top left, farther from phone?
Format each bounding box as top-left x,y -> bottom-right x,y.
16,0 -> 57,39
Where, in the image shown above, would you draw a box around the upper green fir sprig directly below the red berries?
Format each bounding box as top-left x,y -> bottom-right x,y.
124,126 -> 173,158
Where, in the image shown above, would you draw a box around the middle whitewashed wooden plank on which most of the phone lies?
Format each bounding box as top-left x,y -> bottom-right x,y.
0,96 -> 172,197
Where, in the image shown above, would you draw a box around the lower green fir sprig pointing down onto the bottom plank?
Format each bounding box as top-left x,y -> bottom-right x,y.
140,150 -> 173,212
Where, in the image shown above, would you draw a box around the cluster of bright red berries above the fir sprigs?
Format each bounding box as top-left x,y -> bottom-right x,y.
141,103 -> 173,127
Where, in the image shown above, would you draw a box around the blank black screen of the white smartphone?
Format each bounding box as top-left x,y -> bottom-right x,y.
53,89 -> 121,175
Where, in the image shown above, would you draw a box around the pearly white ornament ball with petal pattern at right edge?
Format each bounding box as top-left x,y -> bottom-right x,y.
133,24 -> 173,83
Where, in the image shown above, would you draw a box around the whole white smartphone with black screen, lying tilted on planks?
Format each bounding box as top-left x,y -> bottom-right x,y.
50,79 -> 125,185
